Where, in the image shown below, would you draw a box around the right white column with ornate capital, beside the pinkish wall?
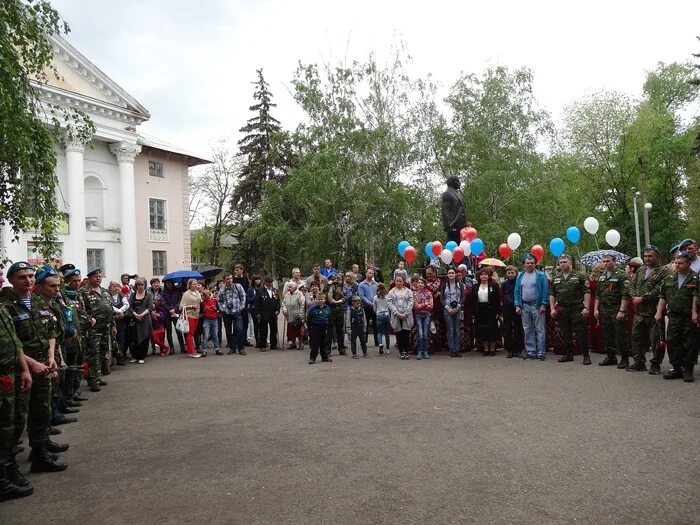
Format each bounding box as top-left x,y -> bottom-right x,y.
109,142 -> 141,273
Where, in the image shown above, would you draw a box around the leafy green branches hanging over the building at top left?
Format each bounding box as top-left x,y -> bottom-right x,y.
0,0 -> 94,257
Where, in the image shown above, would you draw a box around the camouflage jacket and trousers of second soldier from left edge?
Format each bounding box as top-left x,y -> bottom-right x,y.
2,289 -> 60,448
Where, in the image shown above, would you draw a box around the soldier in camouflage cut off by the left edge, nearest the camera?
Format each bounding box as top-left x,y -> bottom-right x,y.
0,298 -> 34,501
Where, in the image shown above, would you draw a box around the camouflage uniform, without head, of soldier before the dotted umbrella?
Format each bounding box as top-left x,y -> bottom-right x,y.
596,270 -> 630,361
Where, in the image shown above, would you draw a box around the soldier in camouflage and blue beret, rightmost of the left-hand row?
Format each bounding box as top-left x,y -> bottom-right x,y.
80,268 -> 116,392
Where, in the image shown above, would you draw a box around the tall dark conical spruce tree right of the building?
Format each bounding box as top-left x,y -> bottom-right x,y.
231,69 -> 293,215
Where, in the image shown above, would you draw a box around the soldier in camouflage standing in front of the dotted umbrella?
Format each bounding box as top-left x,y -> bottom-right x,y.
593,254 -> 630,369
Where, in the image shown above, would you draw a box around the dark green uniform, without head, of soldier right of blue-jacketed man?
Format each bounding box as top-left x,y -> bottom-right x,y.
550,270 -> 591,356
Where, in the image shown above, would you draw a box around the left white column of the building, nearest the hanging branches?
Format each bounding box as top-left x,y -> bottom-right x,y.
62,141 -> 89,274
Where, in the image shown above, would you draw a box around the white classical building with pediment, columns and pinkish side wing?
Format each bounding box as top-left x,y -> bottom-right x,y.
0,37 -> 210,280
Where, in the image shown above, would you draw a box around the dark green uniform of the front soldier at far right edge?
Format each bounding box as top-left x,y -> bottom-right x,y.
660,270 -> 698,374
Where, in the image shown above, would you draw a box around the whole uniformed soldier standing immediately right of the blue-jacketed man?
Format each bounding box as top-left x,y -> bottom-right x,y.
549,254 -> 591,365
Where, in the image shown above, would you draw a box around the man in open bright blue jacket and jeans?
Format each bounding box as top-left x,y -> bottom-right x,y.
515,253 -> 549,361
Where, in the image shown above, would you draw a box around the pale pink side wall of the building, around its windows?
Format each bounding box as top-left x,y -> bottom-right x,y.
134,148 -> 190,277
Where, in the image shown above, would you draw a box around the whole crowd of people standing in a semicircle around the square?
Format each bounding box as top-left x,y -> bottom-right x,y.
0,239 -> 700,501
